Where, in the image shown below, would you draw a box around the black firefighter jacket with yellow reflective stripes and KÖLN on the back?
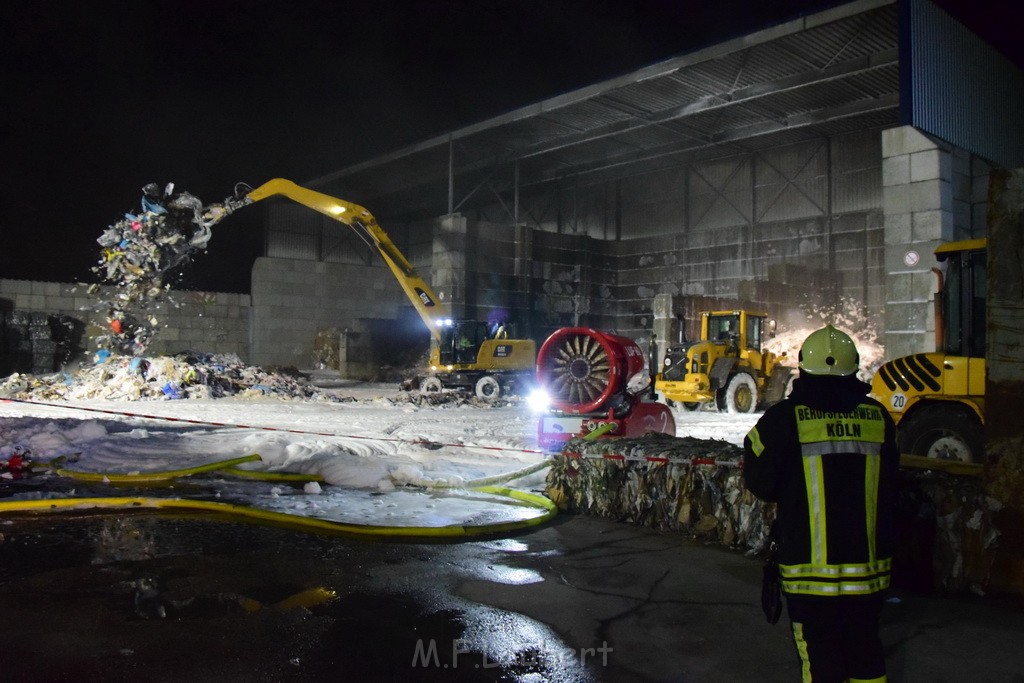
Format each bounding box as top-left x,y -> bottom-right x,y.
743,374 -> 899,596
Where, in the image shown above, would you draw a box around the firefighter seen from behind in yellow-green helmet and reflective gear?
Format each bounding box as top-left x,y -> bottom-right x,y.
743,325 -> 899,682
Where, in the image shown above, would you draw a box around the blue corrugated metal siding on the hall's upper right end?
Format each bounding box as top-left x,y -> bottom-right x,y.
904,0 -> 1024,168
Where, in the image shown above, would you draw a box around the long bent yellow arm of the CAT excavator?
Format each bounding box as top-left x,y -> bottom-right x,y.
224,178 -> 449,341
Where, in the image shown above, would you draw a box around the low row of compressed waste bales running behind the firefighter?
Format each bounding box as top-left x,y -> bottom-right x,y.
546,433 -> 1000,593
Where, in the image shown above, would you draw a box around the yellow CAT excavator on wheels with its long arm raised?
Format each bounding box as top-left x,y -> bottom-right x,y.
212,178 -> 537,400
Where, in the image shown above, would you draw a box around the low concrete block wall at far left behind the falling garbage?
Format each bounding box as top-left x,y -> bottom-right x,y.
0,280 -> 250,371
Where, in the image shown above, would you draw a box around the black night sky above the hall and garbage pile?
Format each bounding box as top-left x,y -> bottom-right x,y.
0,0 -> 1024,292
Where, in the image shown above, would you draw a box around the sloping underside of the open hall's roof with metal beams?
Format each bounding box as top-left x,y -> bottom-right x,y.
308,0 -> 899,219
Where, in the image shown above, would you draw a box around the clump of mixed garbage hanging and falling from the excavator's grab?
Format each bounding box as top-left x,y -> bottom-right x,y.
89,182 -> 228,356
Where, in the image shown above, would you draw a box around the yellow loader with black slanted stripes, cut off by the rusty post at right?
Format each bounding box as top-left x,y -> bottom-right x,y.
871,238 -> 988,463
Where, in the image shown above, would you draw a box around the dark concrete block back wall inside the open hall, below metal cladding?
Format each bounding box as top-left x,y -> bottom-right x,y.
460,209 -> 885,348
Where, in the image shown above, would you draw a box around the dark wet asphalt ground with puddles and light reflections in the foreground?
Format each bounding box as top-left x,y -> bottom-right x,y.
0,512 -> 1024,683
